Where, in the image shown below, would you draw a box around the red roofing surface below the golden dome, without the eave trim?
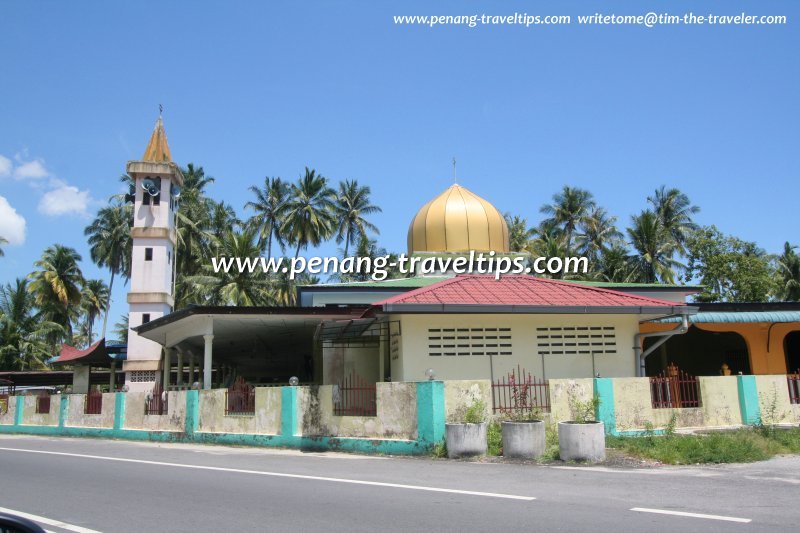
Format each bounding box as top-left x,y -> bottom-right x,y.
375,275 -> 683,307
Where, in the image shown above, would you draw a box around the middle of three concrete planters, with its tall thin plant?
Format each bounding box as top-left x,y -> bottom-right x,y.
501,372 -> 546,459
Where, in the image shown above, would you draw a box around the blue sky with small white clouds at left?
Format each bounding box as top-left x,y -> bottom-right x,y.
0,0 -> 800,332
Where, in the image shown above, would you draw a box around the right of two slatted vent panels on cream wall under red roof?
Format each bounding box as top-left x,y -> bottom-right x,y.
536,326 -> 617,355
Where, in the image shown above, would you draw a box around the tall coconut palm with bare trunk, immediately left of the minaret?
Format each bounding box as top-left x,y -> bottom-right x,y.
83,201 -> 133,338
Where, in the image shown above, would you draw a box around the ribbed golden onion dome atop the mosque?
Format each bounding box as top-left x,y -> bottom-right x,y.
408,184 -> 509,253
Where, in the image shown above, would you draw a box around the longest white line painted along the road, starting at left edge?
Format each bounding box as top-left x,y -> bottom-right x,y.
0,448 -> 536,501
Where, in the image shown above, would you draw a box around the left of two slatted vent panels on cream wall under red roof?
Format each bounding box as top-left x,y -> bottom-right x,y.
428,327 -> 511,357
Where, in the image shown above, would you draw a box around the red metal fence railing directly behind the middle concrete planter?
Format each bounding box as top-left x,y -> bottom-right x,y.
492,366 -> 550,414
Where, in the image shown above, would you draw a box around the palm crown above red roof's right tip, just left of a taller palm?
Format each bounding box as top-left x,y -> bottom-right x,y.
628,209 -> 683,283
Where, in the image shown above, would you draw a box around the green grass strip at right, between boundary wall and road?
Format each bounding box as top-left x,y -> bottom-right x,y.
606,427 -> 800,464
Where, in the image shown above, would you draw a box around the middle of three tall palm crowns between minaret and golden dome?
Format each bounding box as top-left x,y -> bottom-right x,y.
281,167 -> 336,257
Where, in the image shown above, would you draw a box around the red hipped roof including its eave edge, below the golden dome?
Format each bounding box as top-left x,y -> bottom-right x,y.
375,275 -> 696,314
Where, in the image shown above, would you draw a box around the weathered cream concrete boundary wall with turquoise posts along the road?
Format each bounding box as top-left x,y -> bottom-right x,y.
0,376 -> 800,454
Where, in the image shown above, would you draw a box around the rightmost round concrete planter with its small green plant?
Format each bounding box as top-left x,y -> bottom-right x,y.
558,396 -> 606,463
